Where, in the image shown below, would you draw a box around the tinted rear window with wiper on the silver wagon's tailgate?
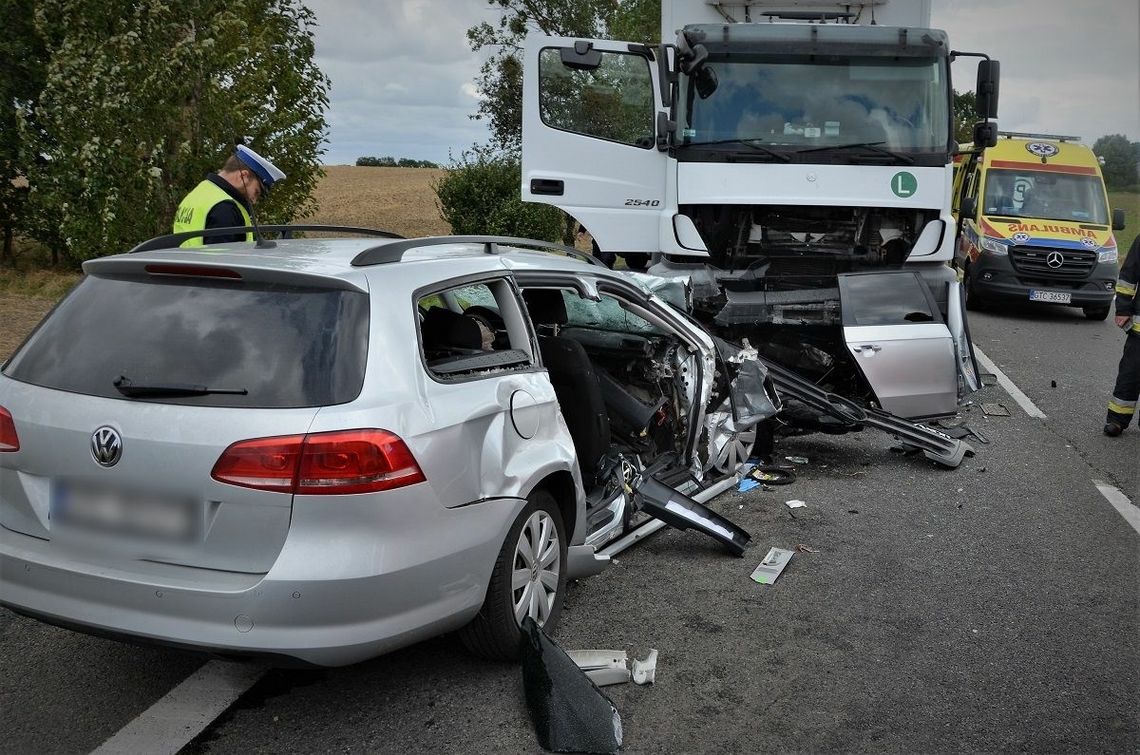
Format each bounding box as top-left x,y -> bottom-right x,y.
3,276 -> 368,408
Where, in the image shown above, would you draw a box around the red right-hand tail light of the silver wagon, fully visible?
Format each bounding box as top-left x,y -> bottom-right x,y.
210,430 -> 425,495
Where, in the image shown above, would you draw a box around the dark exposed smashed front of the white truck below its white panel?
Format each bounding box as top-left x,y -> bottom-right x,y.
668,204 -> 938,400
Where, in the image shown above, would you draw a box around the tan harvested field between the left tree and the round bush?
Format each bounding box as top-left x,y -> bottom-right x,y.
304,165 -> 451,236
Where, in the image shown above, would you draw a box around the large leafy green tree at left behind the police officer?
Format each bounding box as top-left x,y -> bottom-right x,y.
17,0 -> 328,262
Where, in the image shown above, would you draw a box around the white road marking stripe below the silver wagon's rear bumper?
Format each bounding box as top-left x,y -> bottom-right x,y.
92,660 -> 266,755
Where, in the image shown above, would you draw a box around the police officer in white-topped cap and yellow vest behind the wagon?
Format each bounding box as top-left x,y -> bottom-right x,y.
174,144 -> 285,246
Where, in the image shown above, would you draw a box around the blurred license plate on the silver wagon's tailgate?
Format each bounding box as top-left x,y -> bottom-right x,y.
49,482 -> 202,543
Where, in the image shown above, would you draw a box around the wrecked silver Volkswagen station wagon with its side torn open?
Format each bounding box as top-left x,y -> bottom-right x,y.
0,228 -> 779,665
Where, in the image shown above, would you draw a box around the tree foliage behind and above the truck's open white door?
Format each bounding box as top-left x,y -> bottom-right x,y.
467,0 -> 661,152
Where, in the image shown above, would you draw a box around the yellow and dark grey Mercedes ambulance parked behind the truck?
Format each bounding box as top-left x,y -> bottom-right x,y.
953,131 -> 1124,319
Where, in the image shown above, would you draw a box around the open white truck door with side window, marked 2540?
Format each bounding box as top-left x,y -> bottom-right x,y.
522,35 -> 675,253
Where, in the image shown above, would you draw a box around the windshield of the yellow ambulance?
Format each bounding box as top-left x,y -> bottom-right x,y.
983,169 -> 1108,225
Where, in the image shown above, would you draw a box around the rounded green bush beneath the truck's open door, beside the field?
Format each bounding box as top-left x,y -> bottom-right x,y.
433,146 -> 564,241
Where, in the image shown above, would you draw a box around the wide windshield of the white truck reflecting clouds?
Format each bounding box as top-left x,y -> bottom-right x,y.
679,55 -> 950,158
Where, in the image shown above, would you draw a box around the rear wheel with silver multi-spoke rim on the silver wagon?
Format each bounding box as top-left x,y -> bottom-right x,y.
459,488 -> 567,660
